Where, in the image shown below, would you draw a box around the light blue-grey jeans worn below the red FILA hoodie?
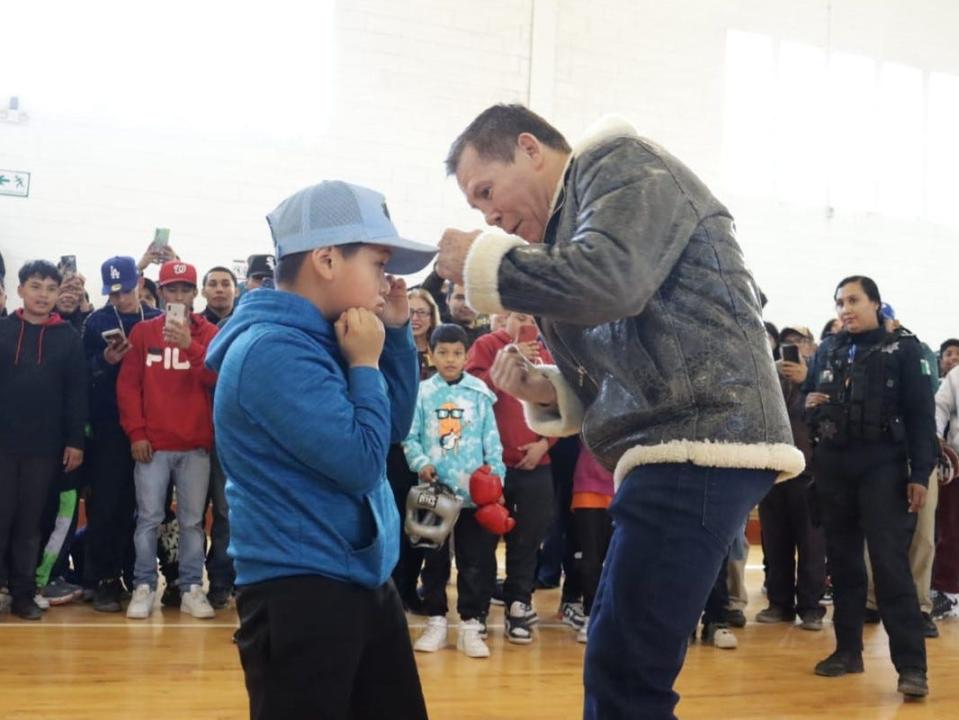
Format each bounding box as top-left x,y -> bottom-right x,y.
133,450 -> 210,591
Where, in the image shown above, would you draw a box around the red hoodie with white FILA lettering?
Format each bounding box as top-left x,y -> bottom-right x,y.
117,313 -> 217,452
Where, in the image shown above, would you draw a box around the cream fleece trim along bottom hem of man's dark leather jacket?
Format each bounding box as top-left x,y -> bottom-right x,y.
613,440 -> 806,487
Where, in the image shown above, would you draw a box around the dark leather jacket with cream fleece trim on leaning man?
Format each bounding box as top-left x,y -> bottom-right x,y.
464,119 -> 804,480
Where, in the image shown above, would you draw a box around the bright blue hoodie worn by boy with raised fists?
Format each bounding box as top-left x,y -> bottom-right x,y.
206,291 -> 419,588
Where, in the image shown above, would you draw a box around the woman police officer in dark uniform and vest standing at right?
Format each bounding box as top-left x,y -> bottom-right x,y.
804,276 -> 938,697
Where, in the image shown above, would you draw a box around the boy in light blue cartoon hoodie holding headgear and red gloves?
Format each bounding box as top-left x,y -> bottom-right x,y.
403,324 -> 506,658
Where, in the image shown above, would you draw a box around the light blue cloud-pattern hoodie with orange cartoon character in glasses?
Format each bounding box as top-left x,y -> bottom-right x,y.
403,372 -> 506,507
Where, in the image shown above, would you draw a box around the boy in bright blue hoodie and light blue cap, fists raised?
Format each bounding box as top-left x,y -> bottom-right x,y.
206,181 -> 435,720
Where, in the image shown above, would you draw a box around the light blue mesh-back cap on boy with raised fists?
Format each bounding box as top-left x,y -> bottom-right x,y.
266,180 -> 437,275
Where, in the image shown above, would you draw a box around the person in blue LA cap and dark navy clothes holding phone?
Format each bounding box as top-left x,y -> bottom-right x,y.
83,256 -> 162,612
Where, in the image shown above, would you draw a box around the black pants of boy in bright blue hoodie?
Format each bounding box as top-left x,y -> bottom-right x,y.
236,575 -> 427,720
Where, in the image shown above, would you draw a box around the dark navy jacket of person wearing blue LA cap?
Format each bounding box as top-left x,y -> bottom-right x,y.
82,304 -> 163,423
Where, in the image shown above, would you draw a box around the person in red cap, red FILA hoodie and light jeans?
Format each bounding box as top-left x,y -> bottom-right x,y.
117,260 -> 217,619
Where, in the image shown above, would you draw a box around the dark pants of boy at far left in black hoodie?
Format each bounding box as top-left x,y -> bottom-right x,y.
0,452 -> 60,600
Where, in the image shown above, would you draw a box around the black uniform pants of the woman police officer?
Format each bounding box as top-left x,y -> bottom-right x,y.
813,443 -> 926,672
